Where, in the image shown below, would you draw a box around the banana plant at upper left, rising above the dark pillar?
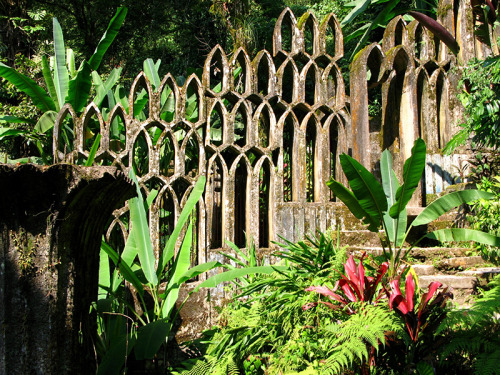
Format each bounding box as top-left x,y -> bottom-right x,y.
0,8 -> 127,161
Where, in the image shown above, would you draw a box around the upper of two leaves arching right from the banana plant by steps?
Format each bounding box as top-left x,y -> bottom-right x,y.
411,189 -> 495,226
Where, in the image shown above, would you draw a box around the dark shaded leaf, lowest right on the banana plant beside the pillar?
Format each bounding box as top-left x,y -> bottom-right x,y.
134,319 -> 172,360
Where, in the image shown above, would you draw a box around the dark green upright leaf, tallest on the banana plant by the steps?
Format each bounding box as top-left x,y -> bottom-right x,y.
389,138 -> 427,218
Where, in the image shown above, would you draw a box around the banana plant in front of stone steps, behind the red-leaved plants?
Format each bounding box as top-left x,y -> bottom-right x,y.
326,139 -> 500,277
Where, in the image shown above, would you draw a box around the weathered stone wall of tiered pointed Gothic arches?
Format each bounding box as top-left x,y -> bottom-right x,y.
49,0 -> 480,268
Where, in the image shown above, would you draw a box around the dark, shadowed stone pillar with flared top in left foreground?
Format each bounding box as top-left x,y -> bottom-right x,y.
0,164 -> 134,375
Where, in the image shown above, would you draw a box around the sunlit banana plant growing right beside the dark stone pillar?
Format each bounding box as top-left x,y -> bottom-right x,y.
96,171 -> 275,374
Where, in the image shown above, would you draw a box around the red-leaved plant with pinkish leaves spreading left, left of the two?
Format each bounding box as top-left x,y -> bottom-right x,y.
302,254 -> 389,314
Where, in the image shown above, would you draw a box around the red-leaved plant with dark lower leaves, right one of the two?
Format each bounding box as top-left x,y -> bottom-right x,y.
388,273 -> 453,343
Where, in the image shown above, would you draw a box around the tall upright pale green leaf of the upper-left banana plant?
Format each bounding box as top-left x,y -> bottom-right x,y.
53,17 -> 69,108
